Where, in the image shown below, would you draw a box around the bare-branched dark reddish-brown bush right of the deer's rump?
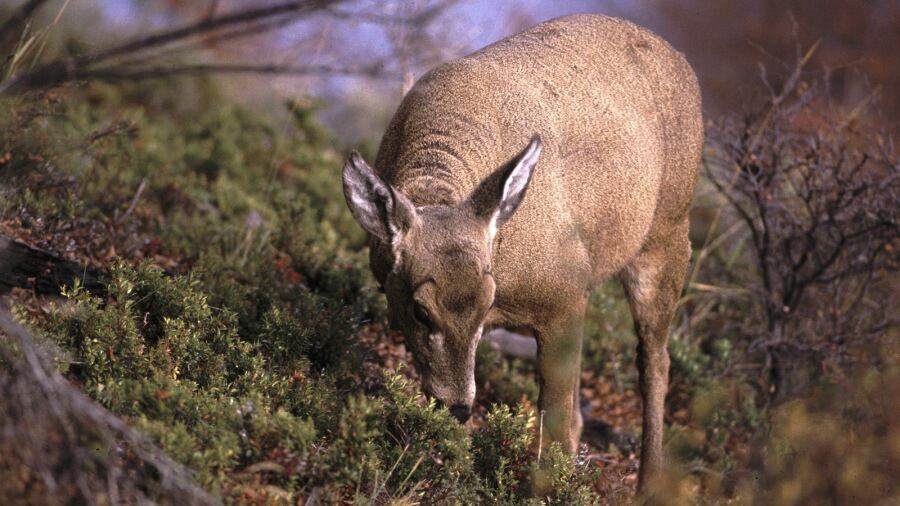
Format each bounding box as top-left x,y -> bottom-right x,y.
705,65 -> 900,400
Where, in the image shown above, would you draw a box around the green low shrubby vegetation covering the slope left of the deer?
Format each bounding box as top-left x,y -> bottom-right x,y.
3,81 -> 590,503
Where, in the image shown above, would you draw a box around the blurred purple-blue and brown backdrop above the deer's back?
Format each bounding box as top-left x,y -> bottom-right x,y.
0,0 -> 900,143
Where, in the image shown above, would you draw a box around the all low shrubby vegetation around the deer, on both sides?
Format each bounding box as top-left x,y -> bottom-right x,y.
0,58 -> 900,504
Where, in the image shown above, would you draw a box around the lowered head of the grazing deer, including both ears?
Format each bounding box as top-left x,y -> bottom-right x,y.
343,136 -> 541,421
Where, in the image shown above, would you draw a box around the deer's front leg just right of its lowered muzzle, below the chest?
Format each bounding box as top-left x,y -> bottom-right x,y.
536,313 -> 584,453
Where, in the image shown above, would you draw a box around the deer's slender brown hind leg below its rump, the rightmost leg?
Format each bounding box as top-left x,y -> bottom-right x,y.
619,219 -> 691,493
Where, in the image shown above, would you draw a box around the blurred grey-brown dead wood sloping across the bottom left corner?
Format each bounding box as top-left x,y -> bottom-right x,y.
0,310 -> 219,505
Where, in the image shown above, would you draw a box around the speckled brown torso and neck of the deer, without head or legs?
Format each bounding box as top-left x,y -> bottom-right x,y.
376,15 -> 702,298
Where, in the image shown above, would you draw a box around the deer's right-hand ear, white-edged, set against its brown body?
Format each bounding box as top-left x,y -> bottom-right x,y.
466,134 -> 541,236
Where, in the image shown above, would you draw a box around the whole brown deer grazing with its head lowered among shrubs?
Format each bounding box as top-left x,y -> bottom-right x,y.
342,14 -> 703,492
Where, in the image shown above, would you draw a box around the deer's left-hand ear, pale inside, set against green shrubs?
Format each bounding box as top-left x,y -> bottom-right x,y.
343,151 -> 416,246
